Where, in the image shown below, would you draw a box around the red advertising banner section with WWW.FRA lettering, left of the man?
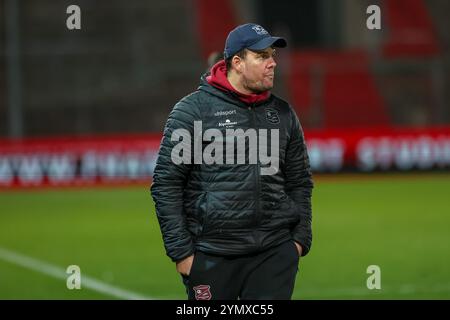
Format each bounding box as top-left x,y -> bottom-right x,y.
0,135 -> 161,188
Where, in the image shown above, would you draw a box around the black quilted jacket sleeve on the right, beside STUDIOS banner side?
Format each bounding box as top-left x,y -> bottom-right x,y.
285,108 -> 313,256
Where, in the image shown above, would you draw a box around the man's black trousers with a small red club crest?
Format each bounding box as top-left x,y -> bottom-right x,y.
182,241 -> 299,300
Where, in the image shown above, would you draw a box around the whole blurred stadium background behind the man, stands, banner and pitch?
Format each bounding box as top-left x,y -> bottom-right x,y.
0,0 -> 450,299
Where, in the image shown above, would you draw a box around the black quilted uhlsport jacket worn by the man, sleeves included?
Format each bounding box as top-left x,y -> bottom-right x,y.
151,77 -> 313,261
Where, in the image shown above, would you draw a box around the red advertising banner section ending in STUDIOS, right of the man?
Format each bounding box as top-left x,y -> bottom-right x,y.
305,127 -> 450,172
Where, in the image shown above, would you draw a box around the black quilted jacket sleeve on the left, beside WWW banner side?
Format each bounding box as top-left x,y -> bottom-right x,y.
151,100 -> 195,262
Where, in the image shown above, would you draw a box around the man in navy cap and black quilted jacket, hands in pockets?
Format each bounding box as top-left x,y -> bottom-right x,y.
151,24 -> 313,300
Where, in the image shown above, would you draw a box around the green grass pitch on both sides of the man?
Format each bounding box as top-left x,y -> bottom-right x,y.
0,174 -> 450,299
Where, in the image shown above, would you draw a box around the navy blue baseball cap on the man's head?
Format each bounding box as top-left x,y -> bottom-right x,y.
223,23 -> 287,59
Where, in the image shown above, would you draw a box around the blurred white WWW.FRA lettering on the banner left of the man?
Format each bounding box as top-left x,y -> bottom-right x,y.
0,150 -> 157,186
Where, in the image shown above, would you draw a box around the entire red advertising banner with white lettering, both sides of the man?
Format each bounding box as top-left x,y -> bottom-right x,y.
0,127 -> 450,189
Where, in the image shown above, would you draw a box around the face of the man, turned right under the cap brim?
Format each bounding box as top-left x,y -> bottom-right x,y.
240,47 -> 277,93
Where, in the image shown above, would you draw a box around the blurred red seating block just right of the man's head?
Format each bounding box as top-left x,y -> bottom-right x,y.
288,50 -> 389,128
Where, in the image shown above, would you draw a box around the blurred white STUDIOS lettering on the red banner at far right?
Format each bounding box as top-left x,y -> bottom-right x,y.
356,136 -> 450,171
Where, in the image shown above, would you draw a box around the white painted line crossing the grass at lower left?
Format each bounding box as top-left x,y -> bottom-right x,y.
0,247 -> 153,300
